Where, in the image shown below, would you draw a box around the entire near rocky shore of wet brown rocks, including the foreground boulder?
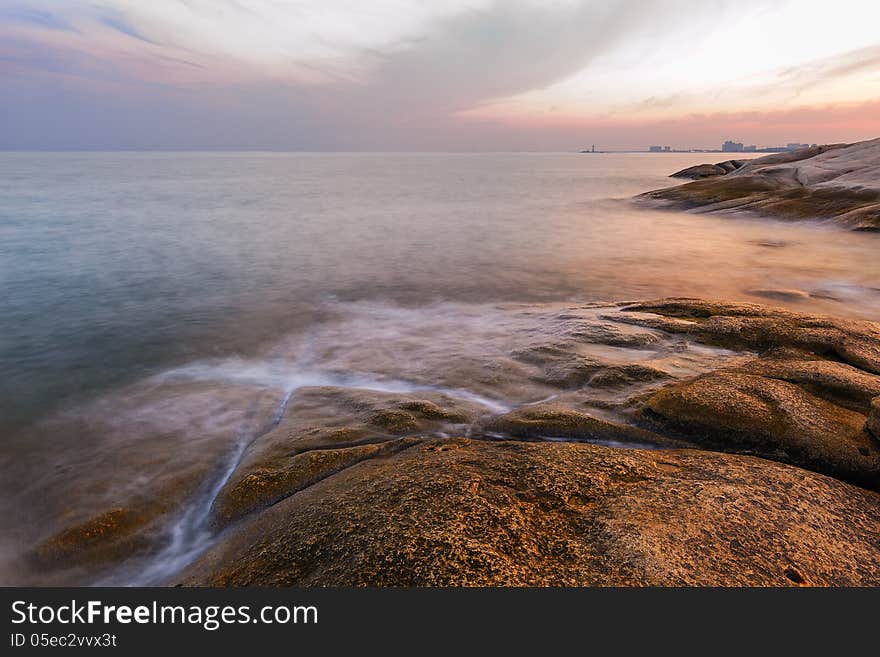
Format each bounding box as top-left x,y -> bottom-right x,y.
22,299 -> 880,586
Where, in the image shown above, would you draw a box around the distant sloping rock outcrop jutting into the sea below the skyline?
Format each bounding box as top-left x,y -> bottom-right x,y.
639,139 -> 880,230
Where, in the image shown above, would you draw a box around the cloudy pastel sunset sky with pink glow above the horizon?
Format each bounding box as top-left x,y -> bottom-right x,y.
0,0 -> 880,151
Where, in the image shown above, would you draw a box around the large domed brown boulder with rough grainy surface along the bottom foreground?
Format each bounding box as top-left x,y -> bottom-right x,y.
179,439 -> 880,586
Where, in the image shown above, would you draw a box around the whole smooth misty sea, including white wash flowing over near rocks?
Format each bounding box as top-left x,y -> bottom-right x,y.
0,154 -> 880,582
